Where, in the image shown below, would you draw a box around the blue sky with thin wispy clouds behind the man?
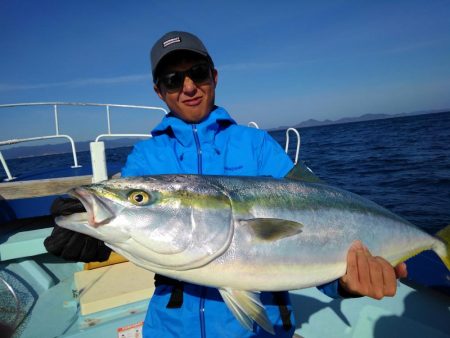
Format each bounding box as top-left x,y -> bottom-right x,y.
0,0 -> 450,141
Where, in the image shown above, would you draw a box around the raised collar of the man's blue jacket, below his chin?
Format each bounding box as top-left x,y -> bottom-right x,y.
152,106 -> 236,146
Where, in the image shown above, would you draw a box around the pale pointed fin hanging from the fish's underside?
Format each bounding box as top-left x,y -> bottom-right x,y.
219,288 -> 275,335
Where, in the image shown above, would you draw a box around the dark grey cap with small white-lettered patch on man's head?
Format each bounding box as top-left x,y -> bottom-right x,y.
150,31 -> 213,80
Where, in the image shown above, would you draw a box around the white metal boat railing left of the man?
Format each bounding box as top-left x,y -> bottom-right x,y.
0,102 -> 168,181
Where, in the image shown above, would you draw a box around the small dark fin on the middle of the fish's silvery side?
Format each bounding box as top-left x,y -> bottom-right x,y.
241,218 -> 303,241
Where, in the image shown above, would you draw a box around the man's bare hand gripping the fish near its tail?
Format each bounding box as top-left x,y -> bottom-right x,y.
339,241 -> 408,299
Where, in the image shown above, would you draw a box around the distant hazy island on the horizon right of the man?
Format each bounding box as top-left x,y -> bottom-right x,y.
269,109 -> 450,131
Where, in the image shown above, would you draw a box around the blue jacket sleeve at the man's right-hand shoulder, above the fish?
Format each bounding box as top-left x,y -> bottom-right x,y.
258,132 -> 294,178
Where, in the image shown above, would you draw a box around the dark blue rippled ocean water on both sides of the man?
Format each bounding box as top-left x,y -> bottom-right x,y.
0,112 -> 450,233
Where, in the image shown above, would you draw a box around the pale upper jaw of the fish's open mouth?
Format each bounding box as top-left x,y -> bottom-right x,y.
69,187 -> 115,228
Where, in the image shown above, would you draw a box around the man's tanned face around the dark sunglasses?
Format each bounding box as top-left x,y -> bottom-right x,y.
154,57 -> 217,123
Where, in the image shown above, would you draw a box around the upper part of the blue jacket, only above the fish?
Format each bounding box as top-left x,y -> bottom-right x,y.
122,108 -> 293,177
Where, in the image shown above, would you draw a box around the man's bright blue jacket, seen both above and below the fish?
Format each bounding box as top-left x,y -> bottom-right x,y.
122,107 -> 338,338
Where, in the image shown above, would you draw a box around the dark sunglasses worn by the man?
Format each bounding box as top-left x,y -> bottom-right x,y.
156,63 -> 211,92
